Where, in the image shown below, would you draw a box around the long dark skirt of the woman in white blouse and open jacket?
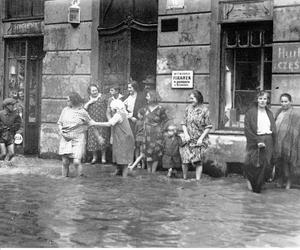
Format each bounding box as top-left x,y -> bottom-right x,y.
244,135 -> 274,193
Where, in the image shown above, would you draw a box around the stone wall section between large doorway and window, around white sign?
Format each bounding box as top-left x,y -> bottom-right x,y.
156,0 -> 211,125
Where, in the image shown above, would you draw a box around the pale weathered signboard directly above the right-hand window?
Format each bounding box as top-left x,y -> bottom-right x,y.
220,0 -> 273,22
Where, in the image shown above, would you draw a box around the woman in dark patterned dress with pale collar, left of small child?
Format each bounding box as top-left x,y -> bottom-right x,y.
144,90 -> 168,173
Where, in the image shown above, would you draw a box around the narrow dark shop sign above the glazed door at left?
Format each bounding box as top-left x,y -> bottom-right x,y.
7,22 -> 42,35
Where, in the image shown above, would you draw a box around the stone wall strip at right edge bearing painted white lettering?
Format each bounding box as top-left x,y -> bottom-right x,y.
272,0 -> 300,111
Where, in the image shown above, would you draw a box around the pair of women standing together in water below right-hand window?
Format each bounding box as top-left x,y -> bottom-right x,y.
244,91 -> 300,193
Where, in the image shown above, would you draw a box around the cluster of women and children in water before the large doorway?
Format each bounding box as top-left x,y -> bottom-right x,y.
58,81 -> 212,180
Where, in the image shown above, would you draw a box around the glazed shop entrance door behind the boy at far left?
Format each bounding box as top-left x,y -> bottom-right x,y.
4,38 -> 43,154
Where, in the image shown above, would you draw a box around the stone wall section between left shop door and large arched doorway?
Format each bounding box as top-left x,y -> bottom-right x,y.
40,0 -> 92,157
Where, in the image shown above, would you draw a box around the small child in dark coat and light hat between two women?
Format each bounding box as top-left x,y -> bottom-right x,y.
162,125 -> 182,177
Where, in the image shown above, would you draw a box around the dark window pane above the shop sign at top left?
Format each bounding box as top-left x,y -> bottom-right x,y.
6,0 -> 44,18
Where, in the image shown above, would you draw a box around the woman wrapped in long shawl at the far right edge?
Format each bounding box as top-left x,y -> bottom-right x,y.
275,93 -> 300,189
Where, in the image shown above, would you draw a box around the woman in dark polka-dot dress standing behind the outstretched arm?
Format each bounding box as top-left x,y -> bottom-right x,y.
84,84 -> 109,164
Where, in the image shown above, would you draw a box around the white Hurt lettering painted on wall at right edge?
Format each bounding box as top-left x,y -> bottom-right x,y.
272,44 -> 300,73
